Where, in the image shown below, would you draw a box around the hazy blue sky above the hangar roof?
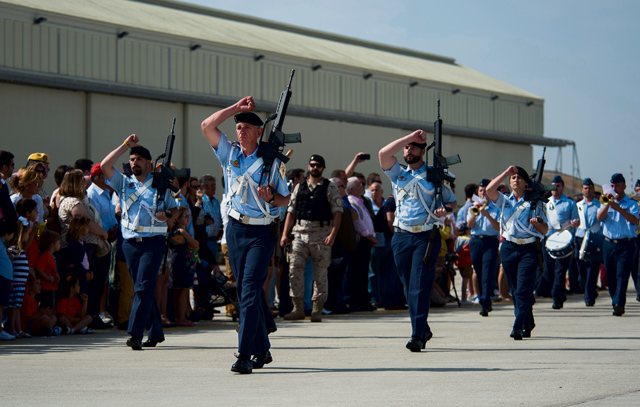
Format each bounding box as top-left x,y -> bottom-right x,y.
183,0 -> 640,187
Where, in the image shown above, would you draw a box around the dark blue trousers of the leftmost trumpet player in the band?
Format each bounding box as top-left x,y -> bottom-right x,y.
469,236 -> 500,310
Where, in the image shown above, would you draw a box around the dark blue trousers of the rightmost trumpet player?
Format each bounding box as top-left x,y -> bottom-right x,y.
602,240 -> 636,308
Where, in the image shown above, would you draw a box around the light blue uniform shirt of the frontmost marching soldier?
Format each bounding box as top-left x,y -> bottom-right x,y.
212,133 -> 289,218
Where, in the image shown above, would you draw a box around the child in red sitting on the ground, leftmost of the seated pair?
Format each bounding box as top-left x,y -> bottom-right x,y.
20,276 -> 62,336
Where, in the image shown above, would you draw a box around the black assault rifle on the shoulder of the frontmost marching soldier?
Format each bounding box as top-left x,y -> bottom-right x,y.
256,69 -> 302,185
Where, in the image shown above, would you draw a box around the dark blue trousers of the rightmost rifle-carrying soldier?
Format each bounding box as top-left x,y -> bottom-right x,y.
500,240 -> 544,329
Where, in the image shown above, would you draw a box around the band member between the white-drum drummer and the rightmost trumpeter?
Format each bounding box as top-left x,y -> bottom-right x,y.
574,178 -> 602,307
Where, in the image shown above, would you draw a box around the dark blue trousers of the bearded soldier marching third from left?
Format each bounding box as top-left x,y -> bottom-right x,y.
391,231 -> 442,341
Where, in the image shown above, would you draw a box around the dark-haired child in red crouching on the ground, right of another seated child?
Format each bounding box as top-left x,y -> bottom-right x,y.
56,275 -> 93,334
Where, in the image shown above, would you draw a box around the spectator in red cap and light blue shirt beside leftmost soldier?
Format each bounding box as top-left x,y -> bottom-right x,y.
87,163 -> 118,324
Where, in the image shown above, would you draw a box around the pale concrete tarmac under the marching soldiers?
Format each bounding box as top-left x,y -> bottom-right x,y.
0,290 -> 640,407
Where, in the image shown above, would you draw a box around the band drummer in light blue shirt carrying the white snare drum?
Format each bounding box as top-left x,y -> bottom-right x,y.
536,175 -> 580,310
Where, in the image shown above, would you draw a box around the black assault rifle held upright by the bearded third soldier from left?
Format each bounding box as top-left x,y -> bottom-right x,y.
422,99 -> 462,264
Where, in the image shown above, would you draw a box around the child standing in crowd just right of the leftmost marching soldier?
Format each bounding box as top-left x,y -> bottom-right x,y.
169,206 -> 200,326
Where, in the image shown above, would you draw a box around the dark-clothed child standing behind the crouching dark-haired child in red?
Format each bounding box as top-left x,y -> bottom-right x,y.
67,215 -> 93,294
